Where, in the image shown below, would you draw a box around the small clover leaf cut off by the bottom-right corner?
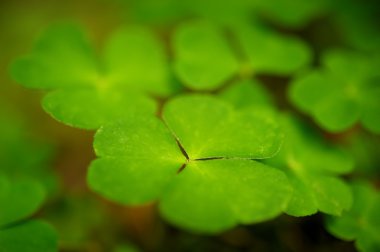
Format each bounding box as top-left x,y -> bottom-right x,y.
327,182 -> 380,252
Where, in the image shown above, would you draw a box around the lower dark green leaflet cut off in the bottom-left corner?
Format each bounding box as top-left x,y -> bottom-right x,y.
0,220 -> 58,252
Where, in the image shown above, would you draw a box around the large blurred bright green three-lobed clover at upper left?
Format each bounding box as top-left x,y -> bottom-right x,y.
12,25 -> 171,129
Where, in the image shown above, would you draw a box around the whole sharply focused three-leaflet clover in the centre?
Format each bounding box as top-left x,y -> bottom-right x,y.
88,95 -> 291,233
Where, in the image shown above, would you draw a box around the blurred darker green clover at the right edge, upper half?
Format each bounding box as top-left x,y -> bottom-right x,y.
289,48 -> 380,133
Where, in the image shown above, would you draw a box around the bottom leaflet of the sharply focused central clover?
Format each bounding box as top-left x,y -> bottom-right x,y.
160,159 -> 291,233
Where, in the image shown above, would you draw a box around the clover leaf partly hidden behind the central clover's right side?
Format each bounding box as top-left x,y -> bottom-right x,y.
266,115 -> 353,216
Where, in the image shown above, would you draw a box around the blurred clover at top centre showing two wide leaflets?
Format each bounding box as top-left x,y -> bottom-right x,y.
173,21 -> 310,90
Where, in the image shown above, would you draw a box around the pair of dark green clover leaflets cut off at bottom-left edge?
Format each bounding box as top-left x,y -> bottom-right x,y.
0,174 -> 58,252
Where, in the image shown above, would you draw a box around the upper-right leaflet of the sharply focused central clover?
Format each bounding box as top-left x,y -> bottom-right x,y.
163,96 -> 282,159
